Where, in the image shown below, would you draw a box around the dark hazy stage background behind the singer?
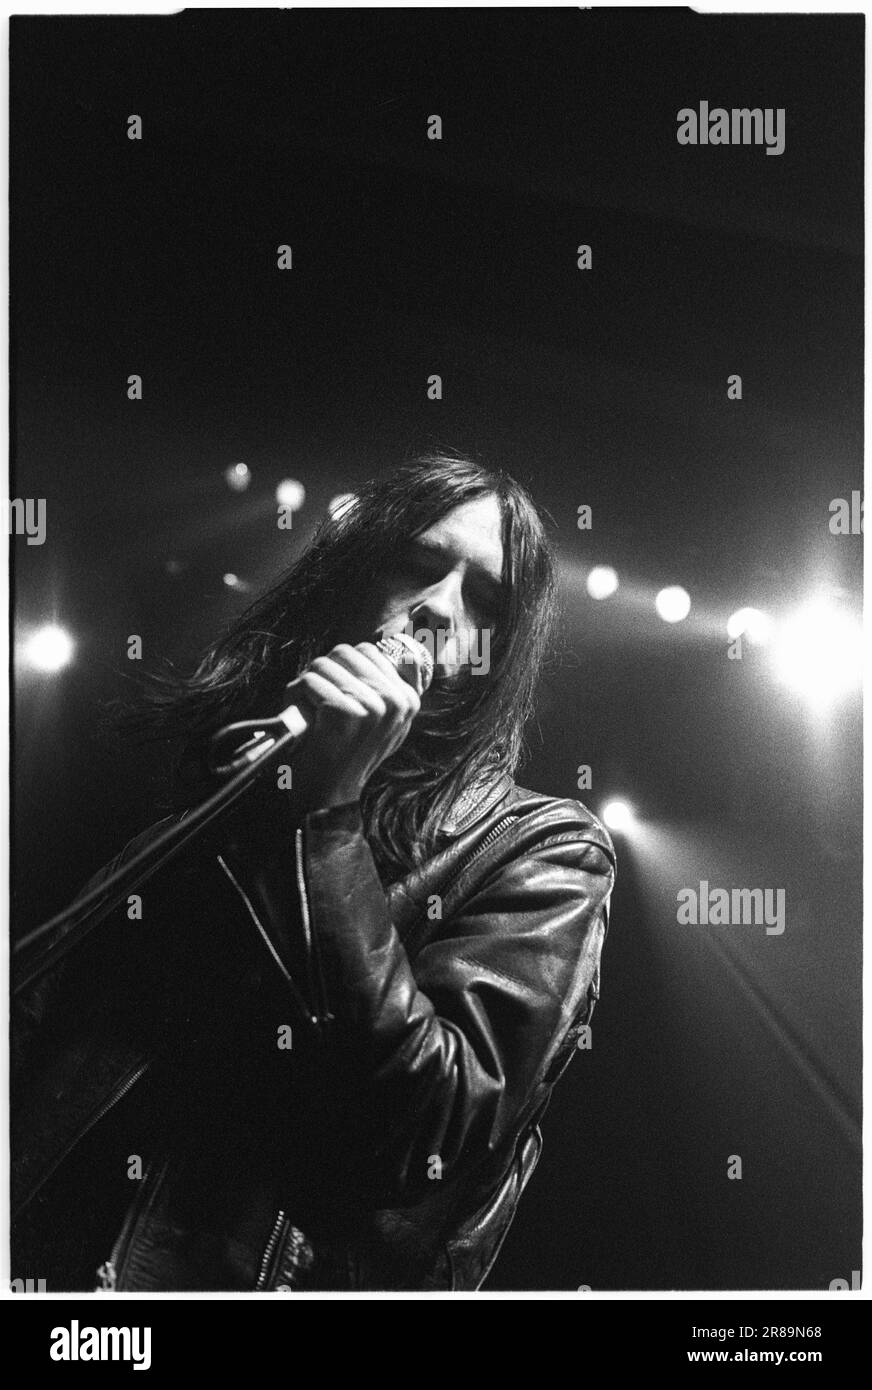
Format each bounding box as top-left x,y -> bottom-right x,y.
10,10 -> 864,1290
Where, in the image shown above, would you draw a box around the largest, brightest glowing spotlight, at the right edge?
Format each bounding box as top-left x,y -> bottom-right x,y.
772,599 -> 862,708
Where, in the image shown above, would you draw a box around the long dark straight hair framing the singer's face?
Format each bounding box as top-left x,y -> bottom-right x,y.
125,450 -> 555,877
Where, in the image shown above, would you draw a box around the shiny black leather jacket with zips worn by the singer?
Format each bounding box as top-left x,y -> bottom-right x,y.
13,777 -> 615,1291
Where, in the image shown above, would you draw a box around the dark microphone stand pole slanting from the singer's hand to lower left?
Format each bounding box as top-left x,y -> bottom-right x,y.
11,721 -> 299,995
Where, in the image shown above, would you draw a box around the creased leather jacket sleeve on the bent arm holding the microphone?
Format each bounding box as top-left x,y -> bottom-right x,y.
303,806 -> 613,1200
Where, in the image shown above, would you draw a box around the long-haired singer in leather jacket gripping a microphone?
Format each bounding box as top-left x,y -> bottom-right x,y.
11,453 -> 615,1291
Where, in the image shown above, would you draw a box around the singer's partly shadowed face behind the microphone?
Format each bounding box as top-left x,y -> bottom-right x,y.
358,495 -> 503,676
